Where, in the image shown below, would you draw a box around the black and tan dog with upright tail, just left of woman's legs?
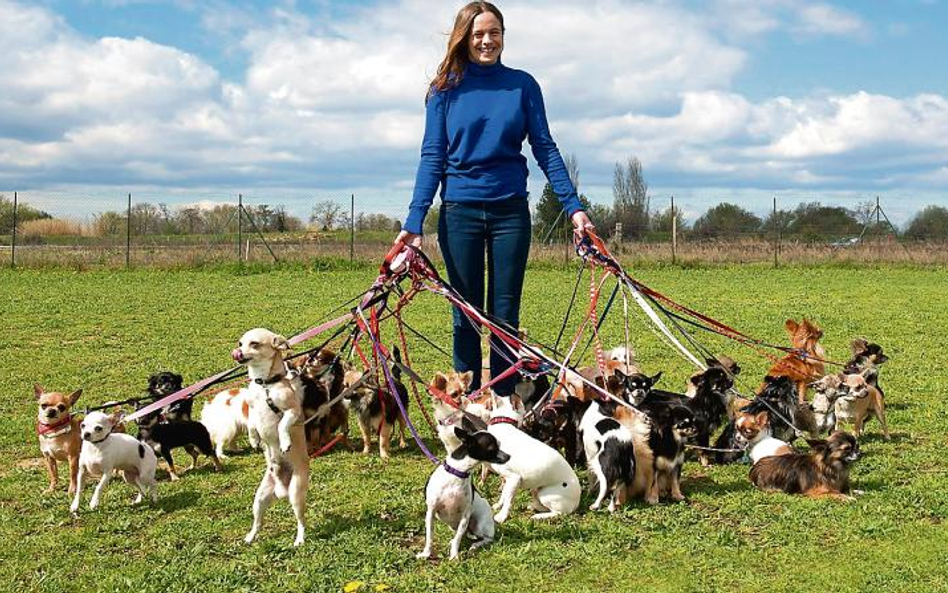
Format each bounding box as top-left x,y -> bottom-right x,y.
343,348 -> 408,459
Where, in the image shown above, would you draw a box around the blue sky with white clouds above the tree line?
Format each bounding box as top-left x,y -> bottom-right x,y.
0,0 -> 948,224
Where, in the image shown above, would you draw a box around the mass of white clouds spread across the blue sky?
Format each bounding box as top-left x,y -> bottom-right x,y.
0,0 -> 948,217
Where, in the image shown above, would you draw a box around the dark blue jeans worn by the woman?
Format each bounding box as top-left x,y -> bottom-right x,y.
438,197 -> 531,396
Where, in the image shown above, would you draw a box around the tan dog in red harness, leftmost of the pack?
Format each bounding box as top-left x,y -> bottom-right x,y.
33,385 -> 82,496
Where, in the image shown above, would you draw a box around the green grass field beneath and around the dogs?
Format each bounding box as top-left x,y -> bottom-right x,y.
0,266 -> 948,593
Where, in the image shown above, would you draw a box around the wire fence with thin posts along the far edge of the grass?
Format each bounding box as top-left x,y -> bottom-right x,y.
0,191 -> 948,268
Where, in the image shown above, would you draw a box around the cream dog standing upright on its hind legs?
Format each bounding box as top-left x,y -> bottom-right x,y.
231,328 -> 309,546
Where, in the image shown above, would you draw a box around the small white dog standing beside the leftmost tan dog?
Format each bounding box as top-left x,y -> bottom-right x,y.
69,412 -> 158,514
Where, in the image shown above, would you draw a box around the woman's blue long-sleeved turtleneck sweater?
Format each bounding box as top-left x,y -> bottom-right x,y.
403,61 -> 582,234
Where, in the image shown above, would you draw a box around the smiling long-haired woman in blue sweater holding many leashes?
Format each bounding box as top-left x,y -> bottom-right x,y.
395,2 -> 593,395
